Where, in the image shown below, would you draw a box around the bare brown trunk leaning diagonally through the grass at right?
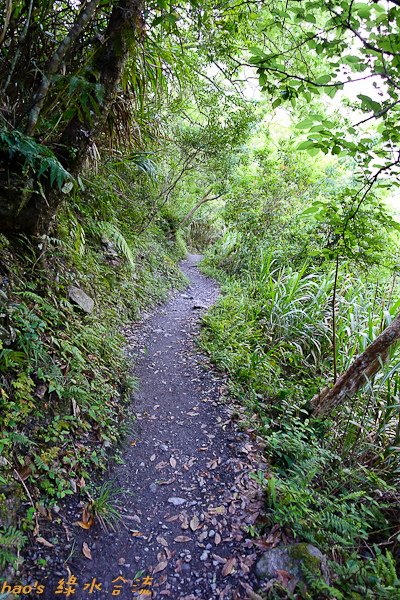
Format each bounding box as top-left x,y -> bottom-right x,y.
311,314 -> 400,416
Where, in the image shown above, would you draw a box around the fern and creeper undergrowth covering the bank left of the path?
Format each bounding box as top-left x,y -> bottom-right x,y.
0,163 -> 185,567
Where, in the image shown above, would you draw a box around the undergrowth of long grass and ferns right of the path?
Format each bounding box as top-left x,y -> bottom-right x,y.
201,129 -> 400,599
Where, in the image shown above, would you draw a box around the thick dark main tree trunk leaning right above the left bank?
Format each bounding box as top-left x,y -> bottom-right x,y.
0,0 -> 143,235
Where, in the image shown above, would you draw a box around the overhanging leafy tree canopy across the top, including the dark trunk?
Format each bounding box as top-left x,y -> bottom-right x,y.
0,0 -> 400,233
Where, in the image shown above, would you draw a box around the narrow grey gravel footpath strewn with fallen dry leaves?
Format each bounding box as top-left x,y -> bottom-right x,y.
36,255 -> 262,600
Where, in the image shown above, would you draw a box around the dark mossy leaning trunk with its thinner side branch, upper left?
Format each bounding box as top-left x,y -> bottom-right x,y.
0,0 -> 143,235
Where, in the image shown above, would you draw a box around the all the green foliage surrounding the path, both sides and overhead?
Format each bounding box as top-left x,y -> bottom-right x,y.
0,0 -> 400,598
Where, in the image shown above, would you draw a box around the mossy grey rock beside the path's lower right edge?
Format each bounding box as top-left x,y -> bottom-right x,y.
256,543 -> 329,584
